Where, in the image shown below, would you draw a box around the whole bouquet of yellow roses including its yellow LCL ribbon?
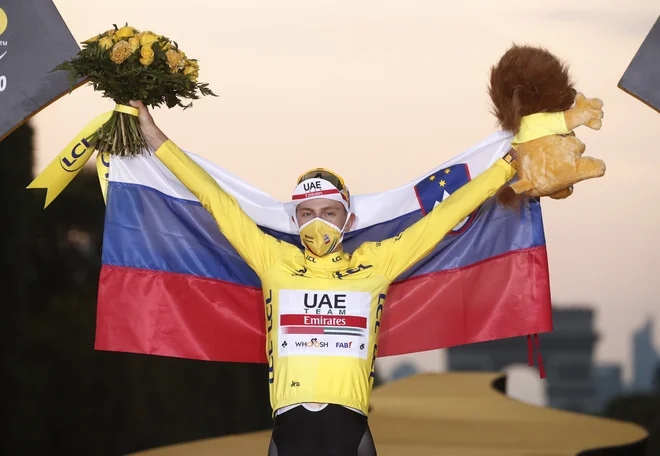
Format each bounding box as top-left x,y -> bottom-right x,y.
28,24 -> 216,206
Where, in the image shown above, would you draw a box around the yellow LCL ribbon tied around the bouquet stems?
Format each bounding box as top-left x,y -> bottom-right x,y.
27,105 -> 138,208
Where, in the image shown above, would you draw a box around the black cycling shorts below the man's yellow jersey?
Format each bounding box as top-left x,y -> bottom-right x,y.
268,404 -> 376,456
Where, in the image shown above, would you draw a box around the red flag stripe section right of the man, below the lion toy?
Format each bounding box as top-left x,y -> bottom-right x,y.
378,246 -> 552,356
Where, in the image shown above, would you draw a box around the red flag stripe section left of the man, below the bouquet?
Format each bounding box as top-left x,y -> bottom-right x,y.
95,265 -> 266,363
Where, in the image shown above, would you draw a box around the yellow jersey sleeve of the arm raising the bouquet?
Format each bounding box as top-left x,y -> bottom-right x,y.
156,140 -> 291,277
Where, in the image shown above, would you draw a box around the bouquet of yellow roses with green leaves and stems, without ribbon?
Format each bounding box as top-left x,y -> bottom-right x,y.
55,24 -> 215,155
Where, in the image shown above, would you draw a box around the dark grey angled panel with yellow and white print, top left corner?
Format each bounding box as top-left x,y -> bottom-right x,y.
0,0 -> 80,140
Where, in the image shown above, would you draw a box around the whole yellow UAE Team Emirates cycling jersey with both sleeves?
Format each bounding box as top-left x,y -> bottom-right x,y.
156,140 -> 515,415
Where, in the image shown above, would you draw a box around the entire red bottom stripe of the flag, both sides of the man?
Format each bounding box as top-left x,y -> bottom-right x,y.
95,246 -> 552,363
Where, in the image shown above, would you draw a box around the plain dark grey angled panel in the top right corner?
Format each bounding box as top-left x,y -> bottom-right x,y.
619,17 -> 660,112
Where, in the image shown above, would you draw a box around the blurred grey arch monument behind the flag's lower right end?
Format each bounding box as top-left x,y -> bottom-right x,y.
447,307 -> 600,413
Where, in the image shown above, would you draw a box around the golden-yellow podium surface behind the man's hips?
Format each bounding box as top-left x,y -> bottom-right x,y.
133,372 -> 648,456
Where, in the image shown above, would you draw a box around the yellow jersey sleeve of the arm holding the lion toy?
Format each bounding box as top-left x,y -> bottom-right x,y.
358,159 -> 516,281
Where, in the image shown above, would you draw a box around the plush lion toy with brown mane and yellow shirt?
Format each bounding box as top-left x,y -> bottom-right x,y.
488,44 -> 605,207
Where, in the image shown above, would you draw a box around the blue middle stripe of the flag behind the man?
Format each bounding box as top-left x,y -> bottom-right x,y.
103,182 -> 545,287
